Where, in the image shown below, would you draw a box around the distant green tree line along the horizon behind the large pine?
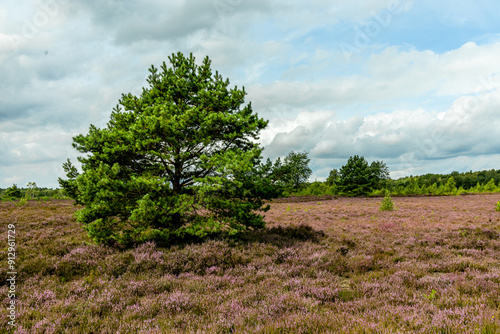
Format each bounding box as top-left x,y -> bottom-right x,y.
0,157 -> 500,200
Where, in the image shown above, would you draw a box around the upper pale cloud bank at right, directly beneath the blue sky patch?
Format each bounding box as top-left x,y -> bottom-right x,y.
249,43 -> 500,113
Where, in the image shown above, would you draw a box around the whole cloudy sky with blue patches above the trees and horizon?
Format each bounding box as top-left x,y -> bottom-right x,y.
0,0 -> 500,188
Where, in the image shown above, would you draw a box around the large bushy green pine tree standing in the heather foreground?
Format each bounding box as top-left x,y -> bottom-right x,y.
59,53 -> 269,244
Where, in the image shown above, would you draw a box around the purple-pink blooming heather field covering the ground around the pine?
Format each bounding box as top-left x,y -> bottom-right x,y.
0,194 -> 500,333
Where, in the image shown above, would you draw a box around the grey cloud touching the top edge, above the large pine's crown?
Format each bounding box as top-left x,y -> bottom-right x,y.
70,0 -> 269,45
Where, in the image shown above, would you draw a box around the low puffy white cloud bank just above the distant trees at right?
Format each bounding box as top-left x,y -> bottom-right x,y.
265,89 -> 500,177
